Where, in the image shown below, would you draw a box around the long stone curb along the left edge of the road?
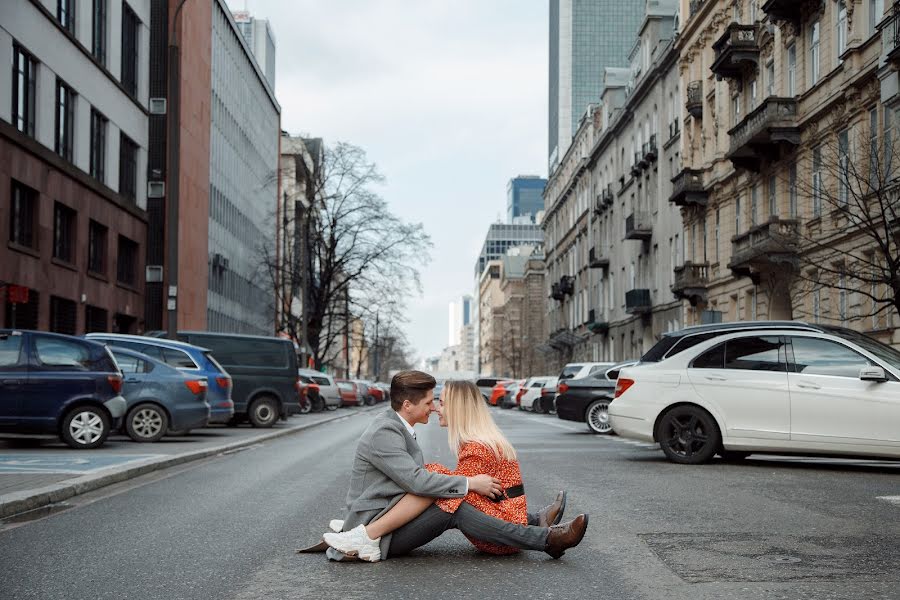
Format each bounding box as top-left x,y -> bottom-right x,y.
0,405 -> 383,520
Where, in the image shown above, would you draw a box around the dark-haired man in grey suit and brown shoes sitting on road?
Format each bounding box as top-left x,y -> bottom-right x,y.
327,371 -> 586,560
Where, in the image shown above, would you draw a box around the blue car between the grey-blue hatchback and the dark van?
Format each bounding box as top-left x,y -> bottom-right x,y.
84,333 -> 234,426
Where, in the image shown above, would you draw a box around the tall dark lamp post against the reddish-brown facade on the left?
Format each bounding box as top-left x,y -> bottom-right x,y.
166,0 -> 187,340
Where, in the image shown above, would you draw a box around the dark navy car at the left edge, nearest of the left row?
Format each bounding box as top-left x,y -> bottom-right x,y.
0,329 -> 127,449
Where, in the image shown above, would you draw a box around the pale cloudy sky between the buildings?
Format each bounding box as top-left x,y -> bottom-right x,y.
228,0 -> 549,357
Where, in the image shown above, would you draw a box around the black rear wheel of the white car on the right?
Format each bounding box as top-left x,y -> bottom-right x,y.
656,405 -> 722,465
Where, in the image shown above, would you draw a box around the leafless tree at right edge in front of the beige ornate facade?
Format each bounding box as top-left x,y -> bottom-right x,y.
785,115 -> 900,324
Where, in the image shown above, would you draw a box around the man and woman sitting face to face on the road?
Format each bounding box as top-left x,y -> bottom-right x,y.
309,371 -> 588,562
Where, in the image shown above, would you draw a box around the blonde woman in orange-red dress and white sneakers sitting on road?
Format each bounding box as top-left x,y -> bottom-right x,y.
324,381 -> 548,562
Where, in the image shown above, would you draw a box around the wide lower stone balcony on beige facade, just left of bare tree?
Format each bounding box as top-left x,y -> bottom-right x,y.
728,217 -> 800,281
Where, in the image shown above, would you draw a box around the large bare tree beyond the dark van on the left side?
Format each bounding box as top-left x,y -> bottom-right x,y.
262,143 -> 432,369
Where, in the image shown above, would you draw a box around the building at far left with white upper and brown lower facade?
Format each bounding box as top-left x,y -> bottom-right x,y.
0,0 -> 150,334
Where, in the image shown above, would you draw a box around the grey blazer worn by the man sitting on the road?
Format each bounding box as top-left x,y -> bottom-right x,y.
336,408 -> 468,557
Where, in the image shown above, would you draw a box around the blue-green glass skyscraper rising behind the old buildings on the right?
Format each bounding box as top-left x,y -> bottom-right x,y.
548,0 -> 645,172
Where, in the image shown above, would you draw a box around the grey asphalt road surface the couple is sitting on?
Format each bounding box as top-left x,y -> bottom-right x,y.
0,409 -> 900,600
